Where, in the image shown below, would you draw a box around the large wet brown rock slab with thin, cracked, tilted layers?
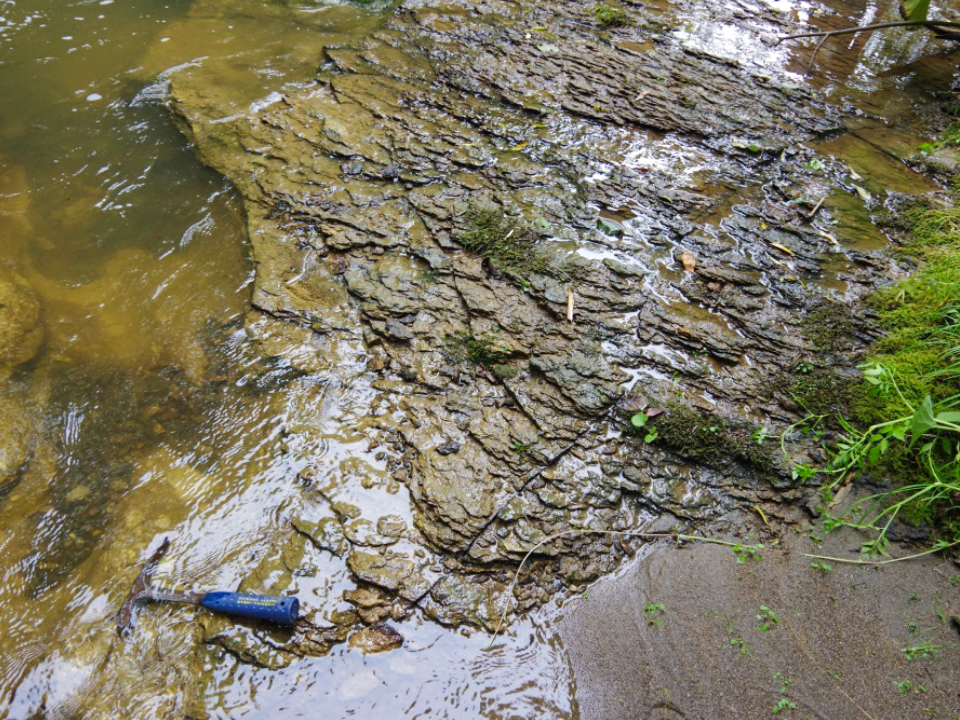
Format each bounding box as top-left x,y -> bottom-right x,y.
161,0 -> 960,667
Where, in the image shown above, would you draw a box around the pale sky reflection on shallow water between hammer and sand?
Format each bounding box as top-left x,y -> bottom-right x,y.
214,623 -> 579,720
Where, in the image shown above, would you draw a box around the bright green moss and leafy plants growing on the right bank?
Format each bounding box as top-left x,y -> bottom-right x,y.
794,197 -> 960,555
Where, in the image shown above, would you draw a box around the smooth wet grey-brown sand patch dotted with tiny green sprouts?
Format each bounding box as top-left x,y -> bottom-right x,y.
560,510 -> 960,720
